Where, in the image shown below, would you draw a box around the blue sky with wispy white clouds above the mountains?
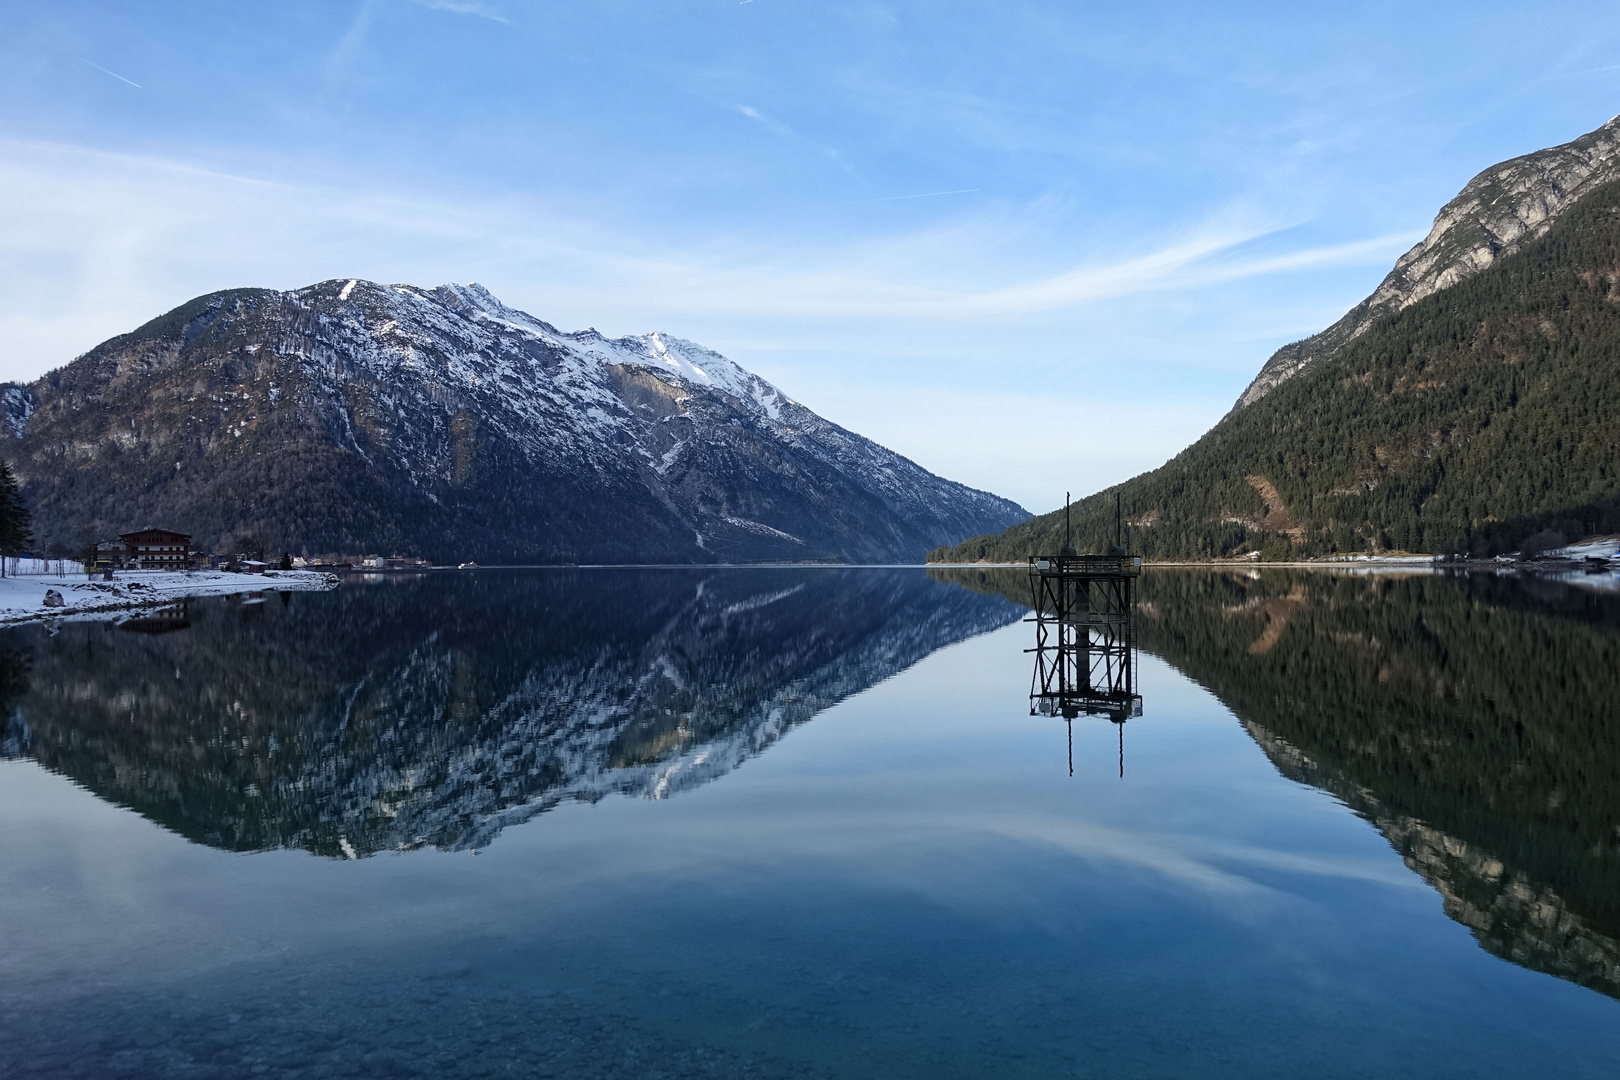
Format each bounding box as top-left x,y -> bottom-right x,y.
0,0 -> 1620,510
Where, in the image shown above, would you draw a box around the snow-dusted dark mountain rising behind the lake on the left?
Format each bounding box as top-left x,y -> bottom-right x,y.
0,280 -> 1027,562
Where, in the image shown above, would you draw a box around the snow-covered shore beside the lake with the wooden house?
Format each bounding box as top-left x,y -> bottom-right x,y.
0,570 -> 337,625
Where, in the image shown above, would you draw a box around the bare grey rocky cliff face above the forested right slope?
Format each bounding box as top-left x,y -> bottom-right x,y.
1238,117 -> 1620,408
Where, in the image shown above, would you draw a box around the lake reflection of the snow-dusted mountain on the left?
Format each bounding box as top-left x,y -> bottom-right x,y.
0,570 -> 1019,858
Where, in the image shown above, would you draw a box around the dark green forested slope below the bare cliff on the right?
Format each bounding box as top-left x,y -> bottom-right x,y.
932,173 -> 1620,562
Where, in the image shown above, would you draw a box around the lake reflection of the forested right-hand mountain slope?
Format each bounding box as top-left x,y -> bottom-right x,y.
935,570 -> 1620,997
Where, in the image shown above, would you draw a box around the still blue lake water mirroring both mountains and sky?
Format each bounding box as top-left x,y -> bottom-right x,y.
0,570 -> 1620,1078
